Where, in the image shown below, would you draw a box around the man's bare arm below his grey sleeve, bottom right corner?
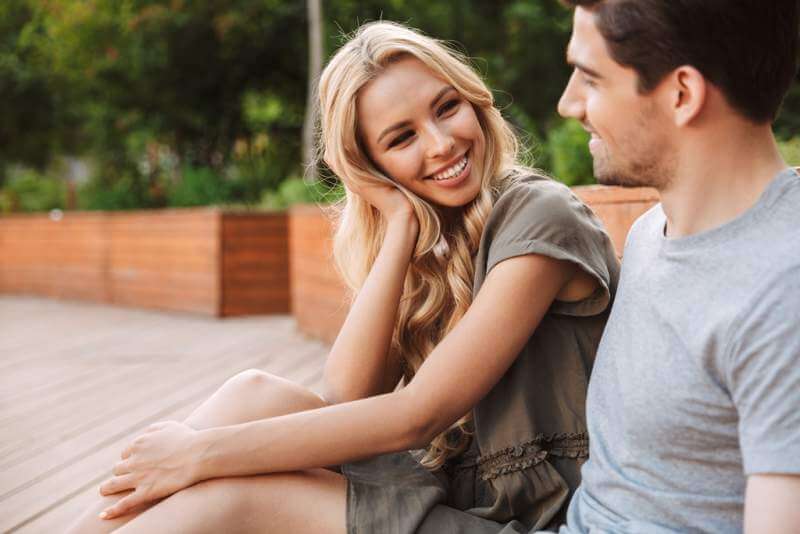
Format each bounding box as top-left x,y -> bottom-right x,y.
744,476 -> 800,534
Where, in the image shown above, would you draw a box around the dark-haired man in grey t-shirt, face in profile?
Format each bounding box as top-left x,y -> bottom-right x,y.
559,0 -> 800,533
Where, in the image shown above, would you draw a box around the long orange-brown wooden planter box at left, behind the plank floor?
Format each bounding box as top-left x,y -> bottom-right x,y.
0,208 -> 289,317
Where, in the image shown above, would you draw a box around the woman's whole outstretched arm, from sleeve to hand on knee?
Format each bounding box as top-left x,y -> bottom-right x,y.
104,254 -> 578,517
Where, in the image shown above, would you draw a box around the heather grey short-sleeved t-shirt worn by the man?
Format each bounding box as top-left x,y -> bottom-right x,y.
561,169 -> 800,534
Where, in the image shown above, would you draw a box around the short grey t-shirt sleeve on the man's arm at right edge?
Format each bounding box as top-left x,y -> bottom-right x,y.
726,266 -> 800,475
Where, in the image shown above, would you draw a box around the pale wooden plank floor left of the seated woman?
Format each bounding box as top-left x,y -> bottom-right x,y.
0,296 -> 327,533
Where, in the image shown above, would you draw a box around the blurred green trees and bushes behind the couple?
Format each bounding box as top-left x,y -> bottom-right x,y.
0,0 -> 800,213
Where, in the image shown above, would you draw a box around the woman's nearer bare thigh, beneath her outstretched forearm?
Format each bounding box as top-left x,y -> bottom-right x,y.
115,469 -> 347,534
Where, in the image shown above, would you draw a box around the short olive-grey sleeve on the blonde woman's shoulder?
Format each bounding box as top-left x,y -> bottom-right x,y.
486,179 -> 618,316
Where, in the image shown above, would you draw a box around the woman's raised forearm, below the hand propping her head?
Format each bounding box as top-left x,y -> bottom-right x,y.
325,213 -> 419,402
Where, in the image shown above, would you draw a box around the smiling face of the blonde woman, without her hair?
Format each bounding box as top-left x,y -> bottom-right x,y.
357,57 -> 486,207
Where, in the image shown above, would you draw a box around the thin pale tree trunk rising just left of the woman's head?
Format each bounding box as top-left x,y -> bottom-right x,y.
303,0 -> 322,182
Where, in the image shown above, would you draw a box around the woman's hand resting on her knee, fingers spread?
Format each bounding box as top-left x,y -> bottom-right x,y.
100,421 -> 199,519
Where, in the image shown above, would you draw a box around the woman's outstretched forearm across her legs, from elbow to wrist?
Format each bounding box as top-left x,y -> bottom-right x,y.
195,390 -> 427,480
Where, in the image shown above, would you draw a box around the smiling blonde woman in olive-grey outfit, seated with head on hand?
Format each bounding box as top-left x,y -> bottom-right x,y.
69,22 -> 618,534
